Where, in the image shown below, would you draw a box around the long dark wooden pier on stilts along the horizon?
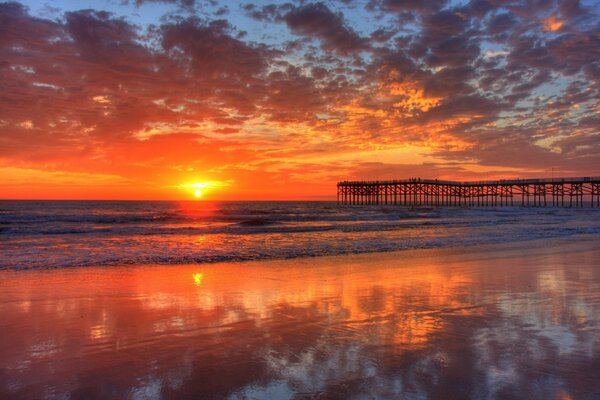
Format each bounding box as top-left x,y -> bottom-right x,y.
337,177 -> 600,207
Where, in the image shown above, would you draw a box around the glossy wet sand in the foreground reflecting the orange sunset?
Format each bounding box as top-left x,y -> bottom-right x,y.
0,236 -> 600,399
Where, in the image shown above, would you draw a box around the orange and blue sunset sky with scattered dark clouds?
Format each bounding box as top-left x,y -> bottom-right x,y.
0,0 -> 600,200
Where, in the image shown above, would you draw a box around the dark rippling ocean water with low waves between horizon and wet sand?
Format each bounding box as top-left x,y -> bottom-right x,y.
0,201 -> 600,269
